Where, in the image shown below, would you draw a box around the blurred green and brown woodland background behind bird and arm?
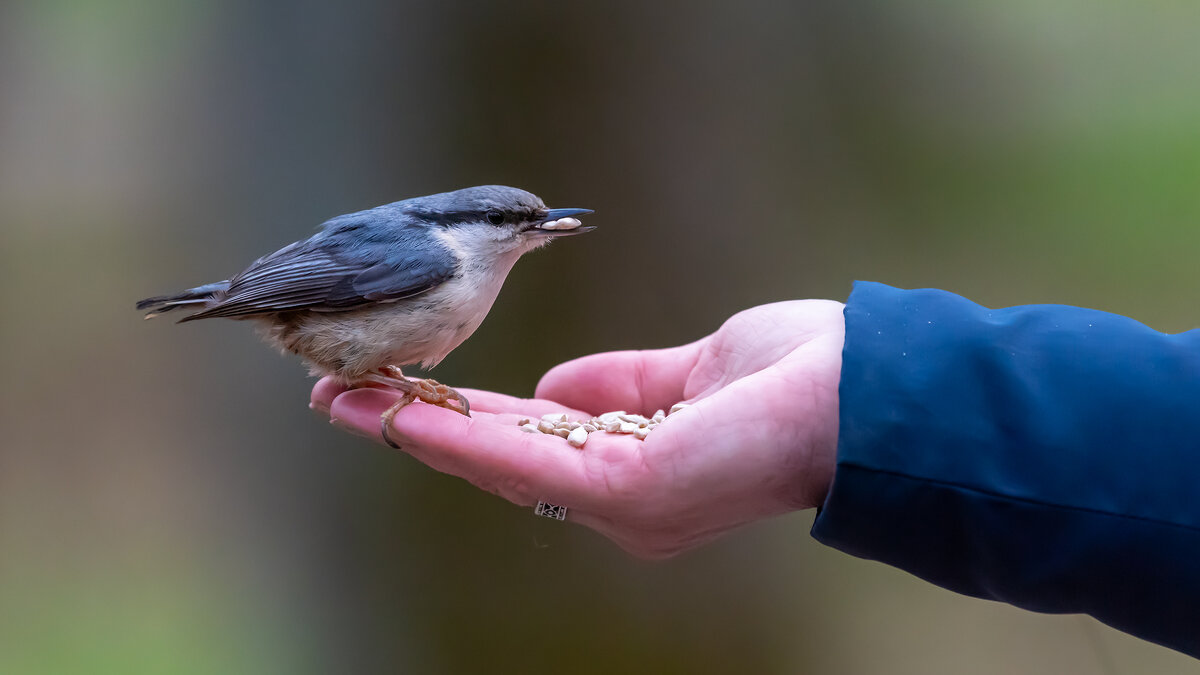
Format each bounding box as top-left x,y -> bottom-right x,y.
0,0 -> 1200,674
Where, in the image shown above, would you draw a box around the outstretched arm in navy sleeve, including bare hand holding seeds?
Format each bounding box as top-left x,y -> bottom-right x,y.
313,283 -> 1200,656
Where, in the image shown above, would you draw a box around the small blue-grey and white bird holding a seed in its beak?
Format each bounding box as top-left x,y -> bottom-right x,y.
137,185 -> 595,448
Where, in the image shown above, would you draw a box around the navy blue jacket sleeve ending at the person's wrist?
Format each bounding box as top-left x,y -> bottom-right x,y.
812,282 -> 1200,657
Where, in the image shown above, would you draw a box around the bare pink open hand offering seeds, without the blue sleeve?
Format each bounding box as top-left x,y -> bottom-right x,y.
312,300 -> 845,557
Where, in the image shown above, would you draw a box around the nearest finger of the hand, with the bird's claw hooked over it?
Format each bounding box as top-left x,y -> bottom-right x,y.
330,389 -> 604,507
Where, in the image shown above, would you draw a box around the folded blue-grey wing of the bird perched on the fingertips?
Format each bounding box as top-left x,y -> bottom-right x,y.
184,227 -> 455,321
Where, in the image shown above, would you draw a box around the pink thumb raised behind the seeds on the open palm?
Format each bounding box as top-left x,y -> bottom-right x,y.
536,338 -> 708,414
